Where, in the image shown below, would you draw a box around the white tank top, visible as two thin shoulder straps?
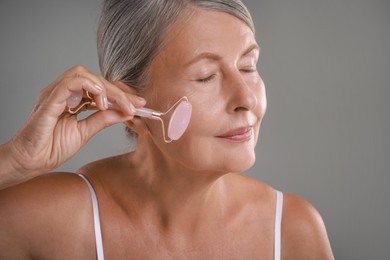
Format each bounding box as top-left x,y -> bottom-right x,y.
78,174 -> 283,260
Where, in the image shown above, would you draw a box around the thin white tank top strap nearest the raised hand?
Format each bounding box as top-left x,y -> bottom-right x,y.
77,174 -> 104,260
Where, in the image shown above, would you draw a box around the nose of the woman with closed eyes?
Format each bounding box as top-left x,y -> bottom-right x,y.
226,71 -> 261,112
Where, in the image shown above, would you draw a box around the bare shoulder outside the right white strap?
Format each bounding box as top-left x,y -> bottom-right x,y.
282,193 -> 334,260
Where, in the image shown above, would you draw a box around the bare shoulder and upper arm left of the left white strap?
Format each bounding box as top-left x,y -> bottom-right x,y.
0,173 -> 92,259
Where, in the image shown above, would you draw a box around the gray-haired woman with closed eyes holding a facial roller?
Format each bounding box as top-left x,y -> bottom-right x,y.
0,0 -> 333,259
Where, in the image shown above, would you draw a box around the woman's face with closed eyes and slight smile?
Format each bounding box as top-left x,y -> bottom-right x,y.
139,9 -> 266,175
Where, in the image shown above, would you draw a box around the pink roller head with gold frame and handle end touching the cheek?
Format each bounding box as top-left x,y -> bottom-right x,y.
135,97 -> 192,143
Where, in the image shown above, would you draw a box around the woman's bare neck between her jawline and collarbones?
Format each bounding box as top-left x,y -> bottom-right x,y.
120,136 -> 224,230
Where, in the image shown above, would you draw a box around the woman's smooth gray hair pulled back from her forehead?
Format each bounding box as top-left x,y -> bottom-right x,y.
97,0 -> 254,140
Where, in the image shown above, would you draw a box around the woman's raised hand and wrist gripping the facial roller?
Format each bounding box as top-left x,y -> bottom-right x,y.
0,66 -> 145,188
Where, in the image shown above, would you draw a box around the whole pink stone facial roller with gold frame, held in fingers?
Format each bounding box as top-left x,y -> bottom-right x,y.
68,92 -> 192,143
